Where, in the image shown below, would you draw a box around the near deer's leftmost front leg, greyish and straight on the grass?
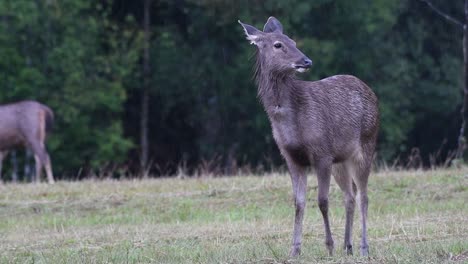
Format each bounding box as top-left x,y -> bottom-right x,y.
288,161 -> 307,257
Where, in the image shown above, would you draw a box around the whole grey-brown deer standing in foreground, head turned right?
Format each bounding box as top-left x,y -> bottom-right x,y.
239,17 -> 379,256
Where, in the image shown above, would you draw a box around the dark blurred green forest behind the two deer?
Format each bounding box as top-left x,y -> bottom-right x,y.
0,0 -> 464,179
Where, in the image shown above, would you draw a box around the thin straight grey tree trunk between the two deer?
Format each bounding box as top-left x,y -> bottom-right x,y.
140,0 -> 151,177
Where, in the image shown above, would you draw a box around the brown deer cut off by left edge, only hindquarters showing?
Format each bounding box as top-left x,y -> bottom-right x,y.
0,101 -> 54,183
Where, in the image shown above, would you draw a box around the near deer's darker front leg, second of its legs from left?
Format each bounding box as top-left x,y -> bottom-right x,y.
316,159 -> 334,256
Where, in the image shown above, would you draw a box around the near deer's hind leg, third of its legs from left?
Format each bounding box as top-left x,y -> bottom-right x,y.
333,161 -> 356,255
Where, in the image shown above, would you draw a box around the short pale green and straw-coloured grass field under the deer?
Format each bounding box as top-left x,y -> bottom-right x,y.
0,168 -> 468,263
